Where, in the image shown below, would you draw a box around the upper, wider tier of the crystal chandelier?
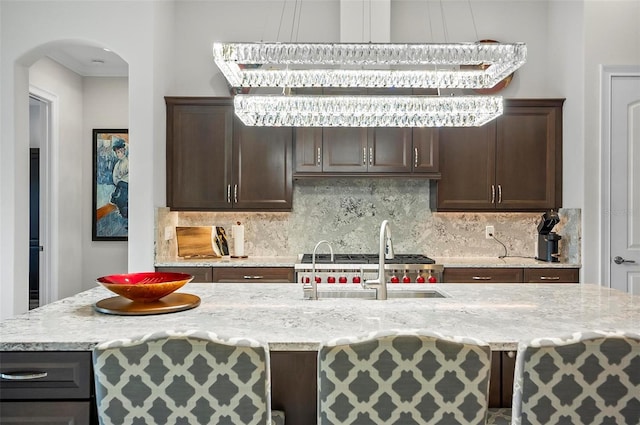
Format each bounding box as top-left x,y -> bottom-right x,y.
213,43 -> 527,89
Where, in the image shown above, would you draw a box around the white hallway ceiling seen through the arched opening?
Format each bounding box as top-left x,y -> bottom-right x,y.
47,45 -> 129,77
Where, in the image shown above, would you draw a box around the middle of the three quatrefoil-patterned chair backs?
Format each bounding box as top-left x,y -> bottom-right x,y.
318,331 -> 491,425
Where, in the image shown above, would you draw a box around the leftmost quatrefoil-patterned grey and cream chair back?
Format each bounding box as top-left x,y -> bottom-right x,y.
93,331 -> 271,425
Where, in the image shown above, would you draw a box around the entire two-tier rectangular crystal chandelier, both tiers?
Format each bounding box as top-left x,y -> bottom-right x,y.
213,42 -> 527,127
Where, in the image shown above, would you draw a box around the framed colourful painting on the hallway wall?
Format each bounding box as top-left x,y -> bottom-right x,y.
92,129 -> 129,241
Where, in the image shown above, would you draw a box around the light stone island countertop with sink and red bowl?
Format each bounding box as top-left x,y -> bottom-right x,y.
0,282 -> 640,351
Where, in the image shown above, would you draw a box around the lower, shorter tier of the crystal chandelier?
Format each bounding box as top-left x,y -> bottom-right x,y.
234,94 -> 502,127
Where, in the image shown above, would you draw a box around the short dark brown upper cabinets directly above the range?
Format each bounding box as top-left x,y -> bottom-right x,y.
295,127 -> 439,177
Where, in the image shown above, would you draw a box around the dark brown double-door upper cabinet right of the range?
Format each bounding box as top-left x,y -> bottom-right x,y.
431,99 -> 564,211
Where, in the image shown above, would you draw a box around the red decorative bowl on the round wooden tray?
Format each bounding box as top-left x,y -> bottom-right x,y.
96,272 -> 193,303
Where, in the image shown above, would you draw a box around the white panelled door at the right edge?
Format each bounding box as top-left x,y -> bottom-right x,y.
605,69 -> 640,294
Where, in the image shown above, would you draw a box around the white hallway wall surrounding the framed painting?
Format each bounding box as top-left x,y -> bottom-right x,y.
81,77 -> 129,290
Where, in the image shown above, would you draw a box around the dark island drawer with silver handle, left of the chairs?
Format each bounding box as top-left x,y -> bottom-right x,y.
0,351 -> 92,400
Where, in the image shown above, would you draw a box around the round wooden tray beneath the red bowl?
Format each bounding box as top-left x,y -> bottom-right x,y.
93,292 -> 200,316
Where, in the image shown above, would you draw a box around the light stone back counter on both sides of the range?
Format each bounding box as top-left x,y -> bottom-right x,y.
155,256 -> 581,268
